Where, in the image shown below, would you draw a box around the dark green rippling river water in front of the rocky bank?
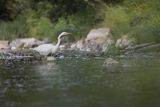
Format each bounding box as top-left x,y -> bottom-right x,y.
0,54 -> 160,107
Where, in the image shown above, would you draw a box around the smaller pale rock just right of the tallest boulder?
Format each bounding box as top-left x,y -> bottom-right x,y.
115,35 -> 134,49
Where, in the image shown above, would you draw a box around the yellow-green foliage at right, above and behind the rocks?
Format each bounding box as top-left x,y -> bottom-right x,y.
101,0 -> 160,43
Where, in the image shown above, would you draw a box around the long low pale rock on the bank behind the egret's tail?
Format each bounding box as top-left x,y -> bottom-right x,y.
10,38 -> 42,49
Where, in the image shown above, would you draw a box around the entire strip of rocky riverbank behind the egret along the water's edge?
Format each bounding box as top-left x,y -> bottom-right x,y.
0,28 -> 160,60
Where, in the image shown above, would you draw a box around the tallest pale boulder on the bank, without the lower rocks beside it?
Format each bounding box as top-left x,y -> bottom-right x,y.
85,28 -> 115,52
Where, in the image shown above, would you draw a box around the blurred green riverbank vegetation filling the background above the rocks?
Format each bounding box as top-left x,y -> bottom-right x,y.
0,0 -> 160,43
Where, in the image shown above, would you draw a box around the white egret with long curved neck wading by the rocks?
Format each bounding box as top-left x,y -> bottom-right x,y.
33,32 -> 70,56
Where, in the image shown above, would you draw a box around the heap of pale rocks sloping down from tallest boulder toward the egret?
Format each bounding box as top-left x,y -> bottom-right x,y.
70,28 -> 115,53
